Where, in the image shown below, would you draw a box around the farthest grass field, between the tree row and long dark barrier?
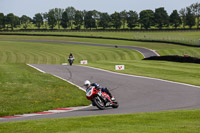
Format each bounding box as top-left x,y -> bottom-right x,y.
6,31 -> 200,45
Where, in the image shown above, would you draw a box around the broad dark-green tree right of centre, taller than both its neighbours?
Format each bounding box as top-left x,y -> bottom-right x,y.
154,7 -> 169,29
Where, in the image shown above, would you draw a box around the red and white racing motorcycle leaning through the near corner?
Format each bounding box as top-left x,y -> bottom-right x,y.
86,86 -> 119,110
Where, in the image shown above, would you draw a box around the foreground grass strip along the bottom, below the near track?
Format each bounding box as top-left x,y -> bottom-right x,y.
0,110 -> 200,133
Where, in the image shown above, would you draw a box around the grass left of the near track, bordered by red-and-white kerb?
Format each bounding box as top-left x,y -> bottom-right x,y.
0,63 -> 90,116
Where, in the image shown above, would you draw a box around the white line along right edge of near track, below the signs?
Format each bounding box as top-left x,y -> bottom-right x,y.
77,65 -> 200,89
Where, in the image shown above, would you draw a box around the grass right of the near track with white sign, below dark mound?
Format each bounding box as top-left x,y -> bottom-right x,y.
89,60 -> 200,86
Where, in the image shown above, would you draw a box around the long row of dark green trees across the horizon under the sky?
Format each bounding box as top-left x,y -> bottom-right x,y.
0,2 -> 200,30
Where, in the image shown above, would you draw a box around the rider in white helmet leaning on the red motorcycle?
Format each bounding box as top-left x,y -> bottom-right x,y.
84,80 -> 115,101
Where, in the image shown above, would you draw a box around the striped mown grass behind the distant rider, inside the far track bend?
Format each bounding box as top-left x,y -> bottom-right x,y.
0,41 -> 143,64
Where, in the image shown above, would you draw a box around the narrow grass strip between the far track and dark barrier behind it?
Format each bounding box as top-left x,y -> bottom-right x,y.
0,35 -> 200,57
